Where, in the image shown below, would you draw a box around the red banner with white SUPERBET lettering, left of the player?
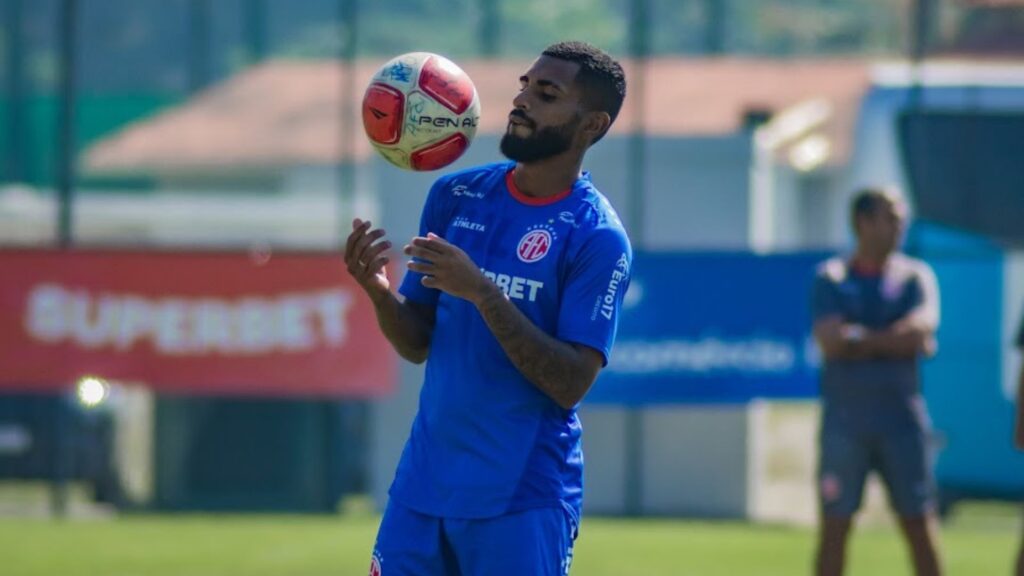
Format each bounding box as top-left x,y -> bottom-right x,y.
0,250 -> 396,398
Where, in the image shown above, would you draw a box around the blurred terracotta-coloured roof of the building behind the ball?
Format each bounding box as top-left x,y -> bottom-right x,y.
84,57 -> 869,173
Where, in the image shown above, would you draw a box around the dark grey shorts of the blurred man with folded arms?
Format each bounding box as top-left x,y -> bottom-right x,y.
818,429 -> 936,518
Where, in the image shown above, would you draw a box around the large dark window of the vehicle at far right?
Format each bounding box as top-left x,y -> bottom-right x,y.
899,111 -> 1024,246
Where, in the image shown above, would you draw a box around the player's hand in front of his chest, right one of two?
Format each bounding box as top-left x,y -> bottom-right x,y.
404,233 -> 494,302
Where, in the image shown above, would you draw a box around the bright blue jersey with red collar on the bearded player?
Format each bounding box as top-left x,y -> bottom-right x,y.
390,162 -> 632,519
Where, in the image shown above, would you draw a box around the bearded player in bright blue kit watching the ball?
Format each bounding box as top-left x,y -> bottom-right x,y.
345,42 -> 632,576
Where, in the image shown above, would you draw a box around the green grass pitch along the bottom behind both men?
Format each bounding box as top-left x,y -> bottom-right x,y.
0,505 -> 1020,576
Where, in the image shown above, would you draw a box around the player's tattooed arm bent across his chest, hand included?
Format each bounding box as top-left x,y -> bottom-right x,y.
406,234 -> 604,409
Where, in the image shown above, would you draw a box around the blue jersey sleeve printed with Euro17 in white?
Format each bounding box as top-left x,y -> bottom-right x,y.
556,228 -> 633,365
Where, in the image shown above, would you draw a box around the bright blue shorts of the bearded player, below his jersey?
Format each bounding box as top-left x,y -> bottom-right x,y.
370,500 -> 577,576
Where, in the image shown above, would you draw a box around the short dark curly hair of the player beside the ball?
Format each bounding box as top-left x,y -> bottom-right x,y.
542,40 -> 626,143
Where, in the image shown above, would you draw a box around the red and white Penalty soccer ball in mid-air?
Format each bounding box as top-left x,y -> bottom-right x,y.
362,52 -> 480,170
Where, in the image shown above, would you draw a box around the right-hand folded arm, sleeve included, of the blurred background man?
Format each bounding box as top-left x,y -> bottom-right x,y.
862,265 -> 939,358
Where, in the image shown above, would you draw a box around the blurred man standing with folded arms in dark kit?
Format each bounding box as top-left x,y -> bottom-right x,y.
811,189 -> 941,576
